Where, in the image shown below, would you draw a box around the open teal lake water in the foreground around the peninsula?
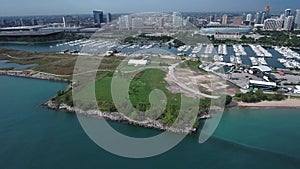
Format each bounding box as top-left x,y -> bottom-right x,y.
0,76 -> 300,169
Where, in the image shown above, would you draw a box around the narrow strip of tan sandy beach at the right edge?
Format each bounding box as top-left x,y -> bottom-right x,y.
238,99 -> 300,108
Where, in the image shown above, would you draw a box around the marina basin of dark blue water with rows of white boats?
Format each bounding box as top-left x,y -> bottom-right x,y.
0,42 -> 300,69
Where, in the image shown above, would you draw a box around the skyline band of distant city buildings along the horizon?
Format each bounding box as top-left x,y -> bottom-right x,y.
0,6 -> 300,32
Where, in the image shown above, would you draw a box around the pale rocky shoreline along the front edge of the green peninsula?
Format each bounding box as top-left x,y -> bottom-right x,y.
43,100 -> 197,135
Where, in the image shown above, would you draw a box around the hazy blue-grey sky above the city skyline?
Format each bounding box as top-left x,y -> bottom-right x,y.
0,0 -> 300,16
